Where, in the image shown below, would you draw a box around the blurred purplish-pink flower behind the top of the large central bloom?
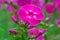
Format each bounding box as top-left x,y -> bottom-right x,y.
17,0 -> 45,7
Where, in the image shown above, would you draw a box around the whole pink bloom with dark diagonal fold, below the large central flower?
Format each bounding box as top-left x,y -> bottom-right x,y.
28,28 -> 46,40
